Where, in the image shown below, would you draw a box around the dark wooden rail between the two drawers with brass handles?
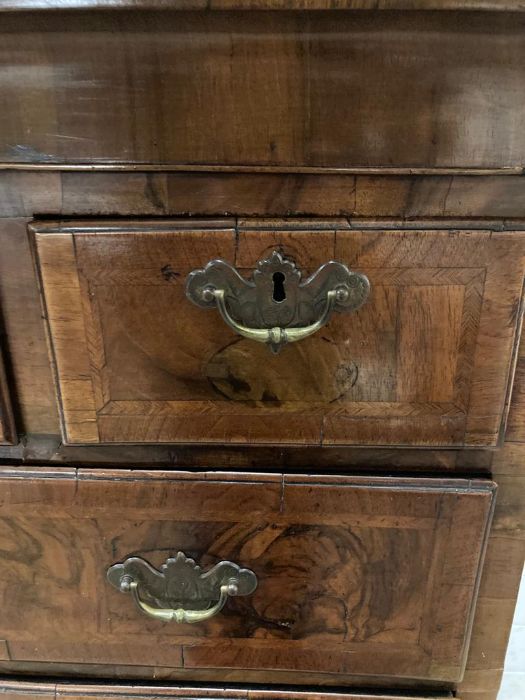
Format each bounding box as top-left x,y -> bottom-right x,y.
0,433 -> 497,476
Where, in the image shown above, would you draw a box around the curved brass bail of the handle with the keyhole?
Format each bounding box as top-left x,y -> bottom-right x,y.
212,287 -> 338,349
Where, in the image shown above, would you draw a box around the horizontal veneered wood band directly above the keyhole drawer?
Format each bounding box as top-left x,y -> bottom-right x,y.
5,169 -> 525,219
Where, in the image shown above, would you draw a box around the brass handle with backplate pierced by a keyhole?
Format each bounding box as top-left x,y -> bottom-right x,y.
186,250 -> 370,353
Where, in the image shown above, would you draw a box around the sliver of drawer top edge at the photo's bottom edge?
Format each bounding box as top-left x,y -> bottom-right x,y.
0,681 -> 450,700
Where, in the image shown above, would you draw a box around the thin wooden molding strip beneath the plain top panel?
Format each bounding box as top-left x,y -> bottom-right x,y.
0,163 -> 525,177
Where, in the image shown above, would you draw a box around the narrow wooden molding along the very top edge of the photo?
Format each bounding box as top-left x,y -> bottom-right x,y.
0,0 -> 525,12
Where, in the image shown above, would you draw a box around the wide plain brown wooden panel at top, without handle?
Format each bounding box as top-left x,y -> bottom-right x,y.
0,12 -> 525,168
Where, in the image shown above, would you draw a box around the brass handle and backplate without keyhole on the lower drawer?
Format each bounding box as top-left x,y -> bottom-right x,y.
107,552 -> 257,624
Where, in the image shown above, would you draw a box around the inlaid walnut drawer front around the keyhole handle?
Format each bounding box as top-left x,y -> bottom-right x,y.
36,222 -> 525,446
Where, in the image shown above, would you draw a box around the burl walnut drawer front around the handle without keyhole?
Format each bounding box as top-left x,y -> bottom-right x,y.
0,467 -> 494,685
